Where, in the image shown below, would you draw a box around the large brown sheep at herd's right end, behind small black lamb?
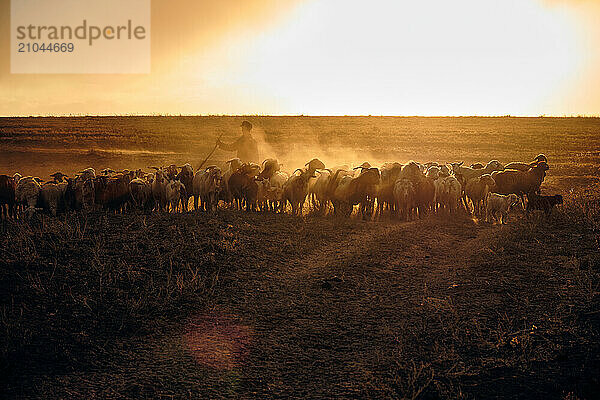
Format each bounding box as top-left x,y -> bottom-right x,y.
492,161 -> 549,200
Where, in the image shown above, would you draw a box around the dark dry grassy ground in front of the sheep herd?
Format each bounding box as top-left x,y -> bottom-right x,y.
0,115 -> 600,399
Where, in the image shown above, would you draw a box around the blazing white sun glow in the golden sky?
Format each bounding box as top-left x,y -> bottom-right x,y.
182,0 -> 581,115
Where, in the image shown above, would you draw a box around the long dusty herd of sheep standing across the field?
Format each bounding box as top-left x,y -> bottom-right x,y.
0,154 -> 562,223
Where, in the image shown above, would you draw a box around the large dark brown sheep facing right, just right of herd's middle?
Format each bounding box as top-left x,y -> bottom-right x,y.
332,168 -> 381,219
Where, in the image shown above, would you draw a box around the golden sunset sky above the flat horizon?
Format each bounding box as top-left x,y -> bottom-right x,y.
0,0 -> 600,116
